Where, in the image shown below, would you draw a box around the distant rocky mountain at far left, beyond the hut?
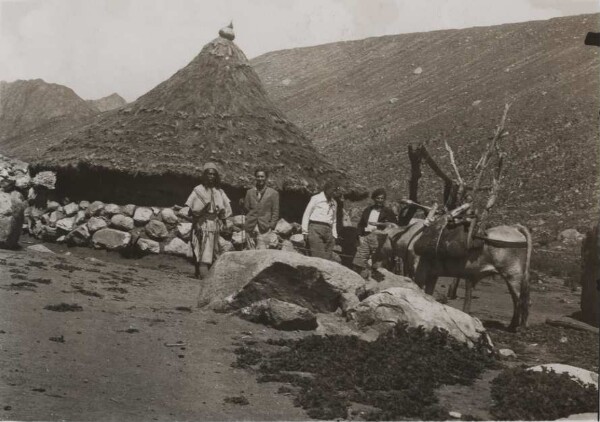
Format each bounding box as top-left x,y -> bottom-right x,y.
0,79 -> 98,143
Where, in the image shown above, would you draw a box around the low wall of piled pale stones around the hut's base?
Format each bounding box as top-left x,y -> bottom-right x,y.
0,156 -> 304,258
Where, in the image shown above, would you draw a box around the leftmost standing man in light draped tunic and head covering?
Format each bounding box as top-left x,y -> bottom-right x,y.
185,163 -> 231,278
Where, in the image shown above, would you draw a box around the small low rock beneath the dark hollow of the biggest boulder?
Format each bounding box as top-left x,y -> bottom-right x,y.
237,299 -> 318,331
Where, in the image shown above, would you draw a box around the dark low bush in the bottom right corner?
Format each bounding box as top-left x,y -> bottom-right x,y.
492,368 -> 598,421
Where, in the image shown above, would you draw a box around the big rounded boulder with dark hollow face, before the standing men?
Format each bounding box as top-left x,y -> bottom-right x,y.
198,250 -> 365,312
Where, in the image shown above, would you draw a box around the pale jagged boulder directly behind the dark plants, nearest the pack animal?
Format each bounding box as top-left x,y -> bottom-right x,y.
347,286 -> 488,346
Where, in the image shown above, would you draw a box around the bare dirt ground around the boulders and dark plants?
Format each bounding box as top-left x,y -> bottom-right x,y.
0,239 -> 592,421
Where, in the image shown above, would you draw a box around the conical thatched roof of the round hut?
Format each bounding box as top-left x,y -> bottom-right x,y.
32,33 -> 364,196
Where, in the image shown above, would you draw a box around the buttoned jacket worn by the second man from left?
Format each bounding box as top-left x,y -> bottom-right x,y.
244,187 -> 279,233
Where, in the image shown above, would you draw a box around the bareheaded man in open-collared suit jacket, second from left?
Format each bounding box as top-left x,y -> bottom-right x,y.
244,168 -> 279,249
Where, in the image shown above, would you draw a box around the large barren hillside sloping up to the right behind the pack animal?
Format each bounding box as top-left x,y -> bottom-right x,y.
253,15 -> 600,231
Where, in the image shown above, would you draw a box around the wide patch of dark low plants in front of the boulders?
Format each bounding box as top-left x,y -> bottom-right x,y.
235,326 -> 497,420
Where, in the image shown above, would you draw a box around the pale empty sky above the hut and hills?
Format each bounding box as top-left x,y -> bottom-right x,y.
0,0 -> 600,101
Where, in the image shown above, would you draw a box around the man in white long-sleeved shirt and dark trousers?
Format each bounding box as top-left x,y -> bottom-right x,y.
302,182 -> 339,260
